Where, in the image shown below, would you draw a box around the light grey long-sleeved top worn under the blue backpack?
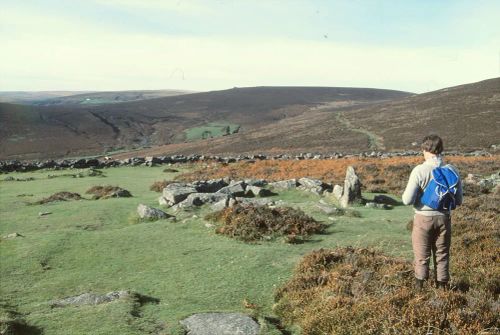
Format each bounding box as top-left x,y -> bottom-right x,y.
402,157 -> 463,216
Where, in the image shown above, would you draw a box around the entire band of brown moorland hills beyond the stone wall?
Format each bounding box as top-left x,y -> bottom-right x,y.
0,78 -> 500,159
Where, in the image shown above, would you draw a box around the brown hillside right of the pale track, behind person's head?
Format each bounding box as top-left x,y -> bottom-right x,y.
343,78 -> 500,150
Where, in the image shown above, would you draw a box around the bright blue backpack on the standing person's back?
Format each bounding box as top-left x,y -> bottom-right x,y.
420,165 -> 460,211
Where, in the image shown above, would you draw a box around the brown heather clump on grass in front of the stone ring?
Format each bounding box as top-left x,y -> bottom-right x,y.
207,205 -> 326,243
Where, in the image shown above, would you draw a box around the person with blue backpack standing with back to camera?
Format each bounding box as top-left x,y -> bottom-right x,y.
402,135 -> 462,289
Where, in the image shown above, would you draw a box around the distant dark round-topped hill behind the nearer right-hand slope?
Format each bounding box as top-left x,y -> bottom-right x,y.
0,87 -> 410,159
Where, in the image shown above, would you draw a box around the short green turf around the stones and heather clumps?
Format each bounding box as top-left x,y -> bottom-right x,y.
0,166 -> 412,335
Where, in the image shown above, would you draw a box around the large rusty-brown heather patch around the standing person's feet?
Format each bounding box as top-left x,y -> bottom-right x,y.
275,195 -> 500,335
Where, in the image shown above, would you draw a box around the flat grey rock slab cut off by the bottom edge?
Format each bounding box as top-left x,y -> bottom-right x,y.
180,313 -> 260,335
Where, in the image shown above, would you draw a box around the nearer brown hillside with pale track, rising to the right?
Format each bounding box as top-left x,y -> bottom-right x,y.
110,78 -> 500,156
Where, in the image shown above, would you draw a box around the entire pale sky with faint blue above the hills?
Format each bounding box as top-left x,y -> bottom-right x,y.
0,0 -> 500,93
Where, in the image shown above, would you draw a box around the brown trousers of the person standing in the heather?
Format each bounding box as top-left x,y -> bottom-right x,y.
411,214 -> 451,282
